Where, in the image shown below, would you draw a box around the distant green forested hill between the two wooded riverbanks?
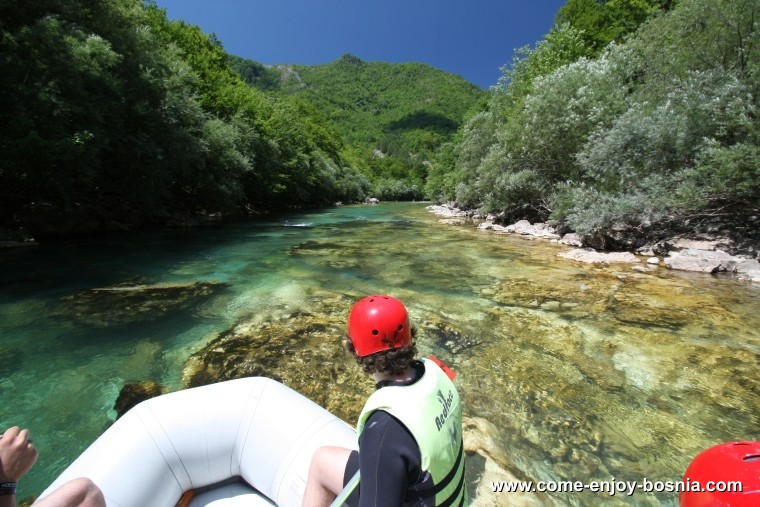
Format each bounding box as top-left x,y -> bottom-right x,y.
230,54 -> 486,199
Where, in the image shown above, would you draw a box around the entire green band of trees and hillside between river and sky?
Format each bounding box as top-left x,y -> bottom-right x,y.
0,0 -> 760,256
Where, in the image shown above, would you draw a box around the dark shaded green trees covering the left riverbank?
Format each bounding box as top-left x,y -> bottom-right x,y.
0,0 -> 368,233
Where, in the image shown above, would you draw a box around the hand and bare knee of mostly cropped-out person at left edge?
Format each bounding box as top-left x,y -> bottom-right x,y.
0,426 -> 106,507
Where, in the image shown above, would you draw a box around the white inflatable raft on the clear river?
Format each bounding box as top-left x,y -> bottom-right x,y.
41,377 -> 356,507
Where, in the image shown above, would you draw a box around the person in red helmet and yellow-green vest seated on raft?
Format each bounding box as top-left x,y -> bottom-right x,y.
303,295 -> 468,507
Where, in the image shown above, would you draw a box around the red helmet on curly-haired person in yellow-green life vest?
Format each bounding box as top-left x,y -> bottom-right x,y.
348,296 -> 412,357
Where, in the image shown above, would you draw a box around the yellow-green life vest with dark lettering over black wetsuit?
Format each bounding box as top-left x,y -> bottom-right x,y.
356,360 -> 467,506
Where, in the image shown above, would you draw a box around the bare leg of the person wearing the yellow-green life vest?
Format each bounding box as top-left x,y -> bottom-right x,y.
301,446 -> 351,507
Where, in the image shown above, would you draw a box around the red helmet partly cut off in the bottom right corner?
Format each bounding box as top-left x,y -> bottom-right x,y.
681,442 -> 760,507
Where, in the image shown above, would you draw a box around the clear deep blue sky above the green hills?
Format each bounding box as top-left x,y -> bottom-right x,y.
156,0 -> 566,88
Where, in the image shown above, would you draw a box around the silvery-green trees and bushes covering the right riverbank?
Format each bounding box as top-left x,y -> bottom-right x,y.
436,0 -> 760,246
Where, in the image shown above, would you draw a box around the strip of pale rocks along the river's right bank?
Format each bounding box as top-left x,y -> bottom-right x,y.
427,204 -> 760,283
